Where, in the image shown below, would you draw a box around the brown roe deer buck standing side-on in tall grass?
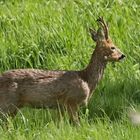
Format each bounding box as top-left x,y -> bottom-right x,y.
0,17 -> 125,123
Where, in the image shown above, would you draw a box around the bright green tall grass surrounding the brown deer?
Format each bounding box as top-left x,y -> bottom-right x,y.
0,0 -> 140,140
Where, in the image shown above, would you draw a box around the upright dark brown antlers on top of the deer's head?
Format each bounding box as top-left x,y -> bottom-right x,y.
97,17 -> 108,40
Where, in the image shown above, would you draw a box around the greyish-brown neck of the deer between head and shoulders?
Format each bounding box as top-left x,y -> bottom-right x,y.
81,48 -> 107,93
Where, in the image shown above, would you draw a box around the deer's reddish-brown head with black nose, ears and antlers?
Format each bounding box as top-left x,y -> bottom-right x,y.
90,17 -> 125,61
